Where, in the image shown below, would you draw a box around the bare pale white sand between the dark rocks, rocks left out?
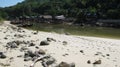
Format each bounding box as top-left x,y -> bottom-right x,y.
0,21 -> 120,67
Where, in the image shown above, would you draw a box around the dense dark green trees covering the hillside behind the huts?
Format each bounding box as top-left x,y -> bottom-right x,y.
0,0 -> 120,19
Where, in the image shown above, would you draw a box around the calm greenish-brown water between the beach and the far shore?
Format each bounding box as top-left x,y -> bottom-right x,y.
27,23 -> 120,39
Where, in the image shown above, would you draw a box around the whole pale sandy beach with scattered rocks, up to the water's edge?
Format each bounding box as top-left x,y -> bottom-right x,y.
0,21 -> 120,67
